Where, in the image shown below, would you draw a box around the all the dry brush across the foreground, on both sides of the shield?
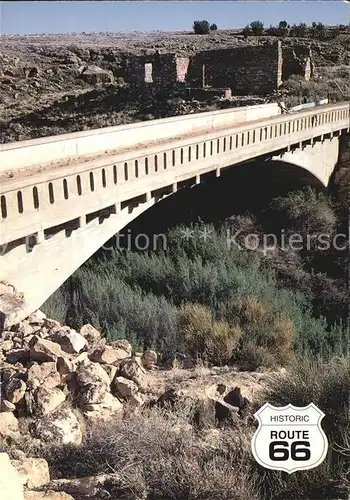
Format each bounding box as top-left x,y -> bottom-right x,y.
12,359 -> 350,500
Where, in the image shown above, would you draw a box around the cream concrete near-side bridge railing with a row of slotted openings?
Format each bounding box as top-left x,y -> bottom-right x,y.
0,103 -> 350,245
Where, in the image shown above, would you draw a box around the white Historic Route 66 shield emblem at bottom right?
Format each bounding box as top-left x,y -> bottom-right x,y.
251,403 -> 328,474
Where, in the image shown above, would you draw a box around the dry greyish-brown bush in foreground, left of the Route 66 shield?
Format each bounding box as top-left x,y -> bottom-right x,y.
32,408 -> 260,500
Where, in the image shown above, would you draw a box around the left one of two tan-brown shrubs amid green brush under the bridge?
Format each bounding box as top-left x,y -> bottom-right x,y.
179,304 -> 242,365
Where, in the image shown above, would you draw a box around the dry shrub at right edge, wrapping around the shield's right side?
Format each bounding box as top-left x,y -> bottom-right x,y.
264,358 -> 350,499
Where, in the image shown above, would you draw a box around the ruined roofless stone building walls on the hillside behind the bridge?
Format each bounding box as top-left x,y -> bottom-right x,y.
111,41 -> 314,95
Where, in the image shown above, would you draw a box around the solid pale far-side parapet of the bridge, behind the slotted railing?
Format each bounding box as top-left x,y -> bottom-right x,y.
0,103 -> 281,171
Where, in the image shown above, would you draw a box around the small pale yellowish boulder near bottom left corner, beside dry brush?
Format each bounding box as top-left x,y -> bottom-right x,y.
11,458 -> 50,488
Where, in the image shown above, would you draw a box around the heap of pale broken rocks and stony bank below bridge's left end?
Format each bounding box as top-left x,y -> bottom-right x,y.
0,292 -> 283,500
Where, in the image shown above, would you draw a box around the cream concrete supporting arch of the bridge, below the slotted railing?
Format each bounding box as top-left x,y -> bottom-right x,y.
0,137 -> 339,327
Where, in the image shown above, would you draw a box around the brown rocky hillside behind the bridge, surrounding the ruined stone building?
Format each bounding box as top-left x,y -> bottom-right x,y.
0,30 -> 350,142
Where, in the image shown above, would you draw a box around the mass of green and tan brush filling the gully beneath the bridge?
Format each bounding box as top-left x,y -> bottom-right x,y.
44,189 -> 347,369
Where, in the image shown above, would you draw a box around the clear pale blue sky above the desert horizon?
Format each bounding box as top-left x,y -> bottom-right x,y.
0,0 -> 350,35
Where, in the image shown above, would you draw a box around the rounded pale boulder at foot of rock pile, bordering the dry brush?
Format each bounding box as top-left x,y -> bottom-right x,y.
31,409 -> 83,445
